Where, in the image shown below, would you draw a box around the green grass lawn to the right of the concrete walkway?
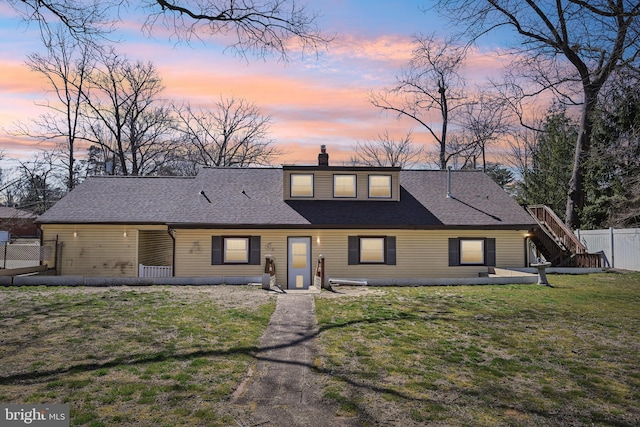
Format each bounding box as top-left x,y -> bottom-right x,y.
316,274 -> 640,426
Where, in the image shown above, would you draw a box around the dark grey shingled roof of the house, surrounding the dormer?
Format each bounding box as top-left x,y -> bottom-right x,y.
38,168 -> 533,228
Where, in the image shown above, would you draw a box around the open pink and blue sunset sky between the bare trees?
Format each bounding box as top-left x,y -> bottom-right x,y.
0,0 -> 507,168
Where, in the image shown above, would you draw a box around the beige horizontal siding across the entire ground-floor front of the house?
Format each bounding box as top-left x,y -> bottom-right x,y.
42,224 -> 526,286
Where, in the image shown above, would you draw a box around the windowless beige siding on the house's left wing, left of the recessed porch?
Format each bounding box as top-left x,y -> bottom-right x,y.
41,224 -> 167,277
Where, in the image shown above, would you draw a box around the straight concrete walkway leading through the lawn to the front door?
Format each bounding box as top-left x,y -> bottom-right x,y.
231,294 -> 358,427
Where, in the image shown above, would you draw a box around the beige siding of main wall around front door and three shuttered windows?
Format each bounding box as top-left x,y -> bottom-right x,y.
175,230 -> 526,285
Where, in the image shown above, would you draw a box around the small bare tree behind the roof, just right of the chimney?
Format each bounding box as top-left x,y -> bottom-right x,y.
348,130 -> 424,168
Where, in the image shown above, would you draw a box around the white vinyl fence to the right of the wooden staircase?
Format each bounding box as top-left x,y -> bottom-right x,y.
576,228 -> 640,271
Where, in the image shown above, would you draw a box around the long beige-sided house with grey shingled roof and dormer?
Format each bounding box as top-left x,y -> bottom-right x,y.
38,147 -> 535,288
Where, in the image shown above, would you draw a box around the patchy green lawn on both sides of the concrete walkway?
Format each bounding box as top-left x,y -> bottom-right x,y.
0,274 -> 640,426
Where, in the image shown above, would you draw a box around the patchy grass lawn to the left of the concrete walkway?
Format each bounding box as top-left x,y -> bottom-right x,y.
0,287 -> 275,426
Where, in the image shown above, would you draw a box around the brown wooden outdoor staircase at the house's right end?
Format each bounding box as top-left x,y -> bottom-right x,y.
526,205 -> 602,267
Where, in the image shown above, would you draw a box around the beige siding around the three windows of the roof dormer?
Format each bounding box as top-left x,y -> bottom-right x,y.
283,169 -> 400,201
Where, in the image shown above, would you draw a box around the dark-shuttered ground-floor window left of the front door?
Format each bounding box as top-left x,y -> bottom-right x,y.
211,236 -> 261,265
